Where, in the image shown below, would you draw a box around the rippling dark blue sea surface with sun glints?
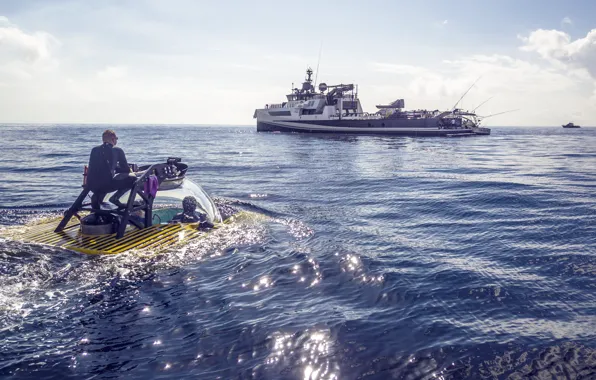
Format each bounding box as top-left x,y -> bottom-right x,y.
0,125 -> 596,379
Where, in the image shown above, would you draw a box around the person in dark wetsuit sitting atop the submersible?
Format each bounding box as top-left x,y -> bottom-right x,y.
87,129 -> 136,209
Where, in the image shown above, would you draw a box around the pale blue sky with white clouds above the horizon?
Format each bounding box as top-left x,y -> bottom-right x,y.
0,0 -> 596,126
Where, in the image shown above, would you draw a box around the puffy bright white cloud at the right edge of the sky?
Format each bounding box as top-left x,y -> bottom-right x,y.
520,29 -> 596,79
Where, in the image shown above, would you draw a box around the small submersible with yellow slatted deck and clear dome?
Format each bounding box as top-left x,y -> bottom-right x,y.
1,157 -> 234,254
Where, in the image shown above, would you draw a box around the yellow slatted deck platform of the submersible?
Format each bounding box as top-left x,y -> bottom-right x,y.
0,219 -> 214,254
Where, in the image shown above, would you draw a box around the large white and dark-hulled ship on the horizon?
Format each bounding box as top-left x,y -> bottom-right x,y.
253,68 -> 490,137
